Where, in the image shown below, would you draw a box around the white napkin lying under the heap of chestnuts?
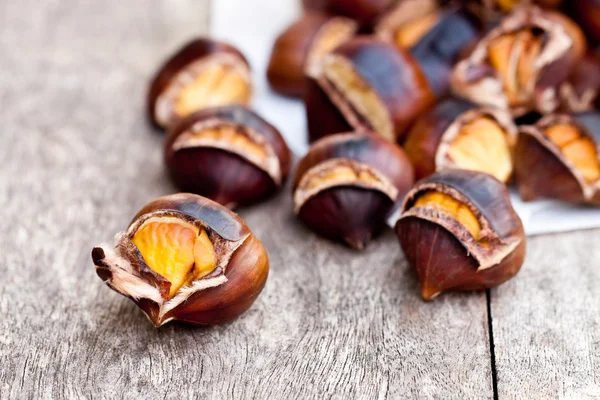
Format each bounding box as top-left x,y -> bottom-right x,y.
211,0 -> 600,235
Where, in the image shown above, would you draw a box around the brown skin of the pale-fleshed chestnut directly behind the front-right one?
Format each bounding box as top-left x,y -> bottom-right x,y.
404,98 -> 517,182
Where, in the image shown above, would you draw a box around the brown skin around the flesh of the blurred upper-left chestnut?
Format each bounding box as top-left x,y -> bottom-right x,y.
147,38 -> 252,129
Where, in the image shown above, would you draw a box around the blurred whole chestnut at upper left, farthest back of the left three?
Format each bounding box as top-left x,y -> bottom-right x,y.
147,38 -> 252,128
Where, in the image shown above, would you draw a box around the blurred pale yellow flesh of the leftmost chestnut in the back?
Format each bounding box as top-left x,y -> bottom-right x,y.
174,64 -> 251,117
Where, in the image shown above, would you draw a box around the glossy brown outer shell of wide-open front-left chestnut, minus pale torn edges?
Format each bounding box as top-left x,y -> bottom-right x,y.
92,193 -> 269,327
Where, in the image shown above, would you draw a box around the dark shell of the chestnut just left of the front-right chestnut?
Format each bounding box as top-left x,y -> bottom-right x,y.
294,133 -> 414,249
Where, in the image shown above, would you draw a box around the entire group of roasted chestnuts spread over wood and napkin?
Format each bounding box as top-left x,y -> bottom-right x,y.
92,0 -> 600,326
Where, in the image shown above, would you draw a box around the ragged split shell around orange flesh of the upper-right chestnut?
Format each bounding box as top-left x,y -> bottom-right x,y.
451,6 -> 586,116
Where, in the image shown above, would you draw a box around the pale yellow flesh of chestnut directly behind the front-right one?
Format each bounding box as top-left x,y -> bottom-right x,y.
448,117 -> 513,182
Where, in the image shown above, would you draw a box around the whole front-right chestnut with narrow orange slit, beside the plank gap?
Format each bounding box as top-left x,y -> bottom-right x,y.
396,169 -> 525,300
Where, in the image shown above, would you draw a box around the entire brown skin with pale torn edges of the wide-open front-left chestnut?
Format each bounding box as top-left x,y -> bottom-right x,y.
92,193 -> 269,327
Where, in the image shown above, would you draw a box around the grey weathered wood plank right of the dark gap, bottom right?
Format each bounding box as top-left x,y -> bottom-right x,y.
491,230 -> 600,399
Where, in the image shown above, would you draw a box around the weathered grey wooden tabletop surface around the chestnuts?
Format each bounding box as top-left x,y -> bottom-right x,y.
0,0 -> 600,399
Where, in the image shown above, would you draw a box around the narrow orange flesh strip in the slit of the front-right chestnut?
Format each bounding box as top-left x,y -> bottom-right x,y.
413,190 -> 481,240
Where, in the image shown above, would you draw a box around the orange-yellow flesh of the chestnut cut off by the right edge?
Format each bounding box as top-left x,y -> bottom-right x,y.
545,124 -> 600,183
